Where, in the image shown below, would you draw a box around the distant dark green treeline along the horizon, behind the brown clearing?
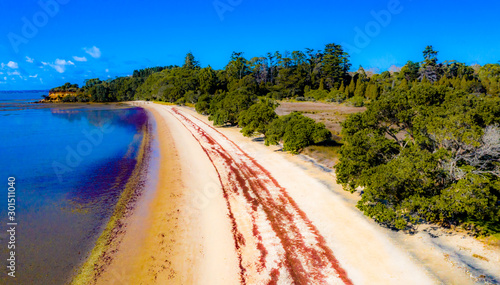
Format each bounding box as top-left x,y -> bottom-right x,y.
50,44 -> 500,106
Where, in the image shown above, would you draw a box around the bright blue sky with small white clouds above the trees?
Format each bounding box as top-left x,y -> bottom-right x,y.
0,0 -> 500,90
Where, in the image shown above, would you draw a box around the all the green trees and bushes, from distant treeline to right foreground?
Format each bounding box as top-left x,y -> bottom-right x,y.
52,44 -> 500,234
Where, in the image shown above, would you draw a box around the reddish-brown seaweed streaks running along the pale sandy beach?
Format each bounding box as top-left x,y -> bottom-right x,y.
167,108 -> 352,284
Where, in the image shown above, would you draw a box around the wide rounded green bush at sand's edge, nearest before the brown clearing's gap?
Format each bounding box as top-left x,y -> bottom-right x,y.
265,112 -> 331,153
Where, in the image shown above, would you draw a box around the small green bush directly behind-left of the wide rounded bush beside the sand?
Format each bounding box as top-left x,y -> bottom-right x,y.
239,99 -> 278,137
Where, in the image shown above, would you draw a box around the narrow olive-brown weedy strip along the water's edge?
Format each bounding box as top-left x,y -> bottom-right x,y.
69,107 -> 154,285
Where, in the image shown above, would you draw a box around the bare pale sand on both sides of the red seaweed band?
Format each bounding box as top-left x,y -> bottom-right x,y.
83,102 -> 498,284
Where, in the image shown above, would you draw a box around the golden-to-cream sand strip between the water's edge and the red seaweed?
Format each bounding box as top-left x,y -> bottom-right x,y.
93,101 -> 239,284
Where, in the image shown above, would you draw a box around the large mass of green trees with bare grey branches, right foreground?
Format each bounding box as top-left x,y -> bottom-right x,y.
336,84 -> 500,232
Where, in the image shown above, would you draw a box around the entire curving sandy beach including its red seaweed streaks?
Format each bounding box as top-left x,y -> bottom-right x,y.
87,102 -> 500,284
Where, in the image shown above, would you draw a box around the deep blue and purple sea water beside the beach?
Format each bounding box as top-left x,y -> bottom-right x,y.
0,91 -> 148,284
